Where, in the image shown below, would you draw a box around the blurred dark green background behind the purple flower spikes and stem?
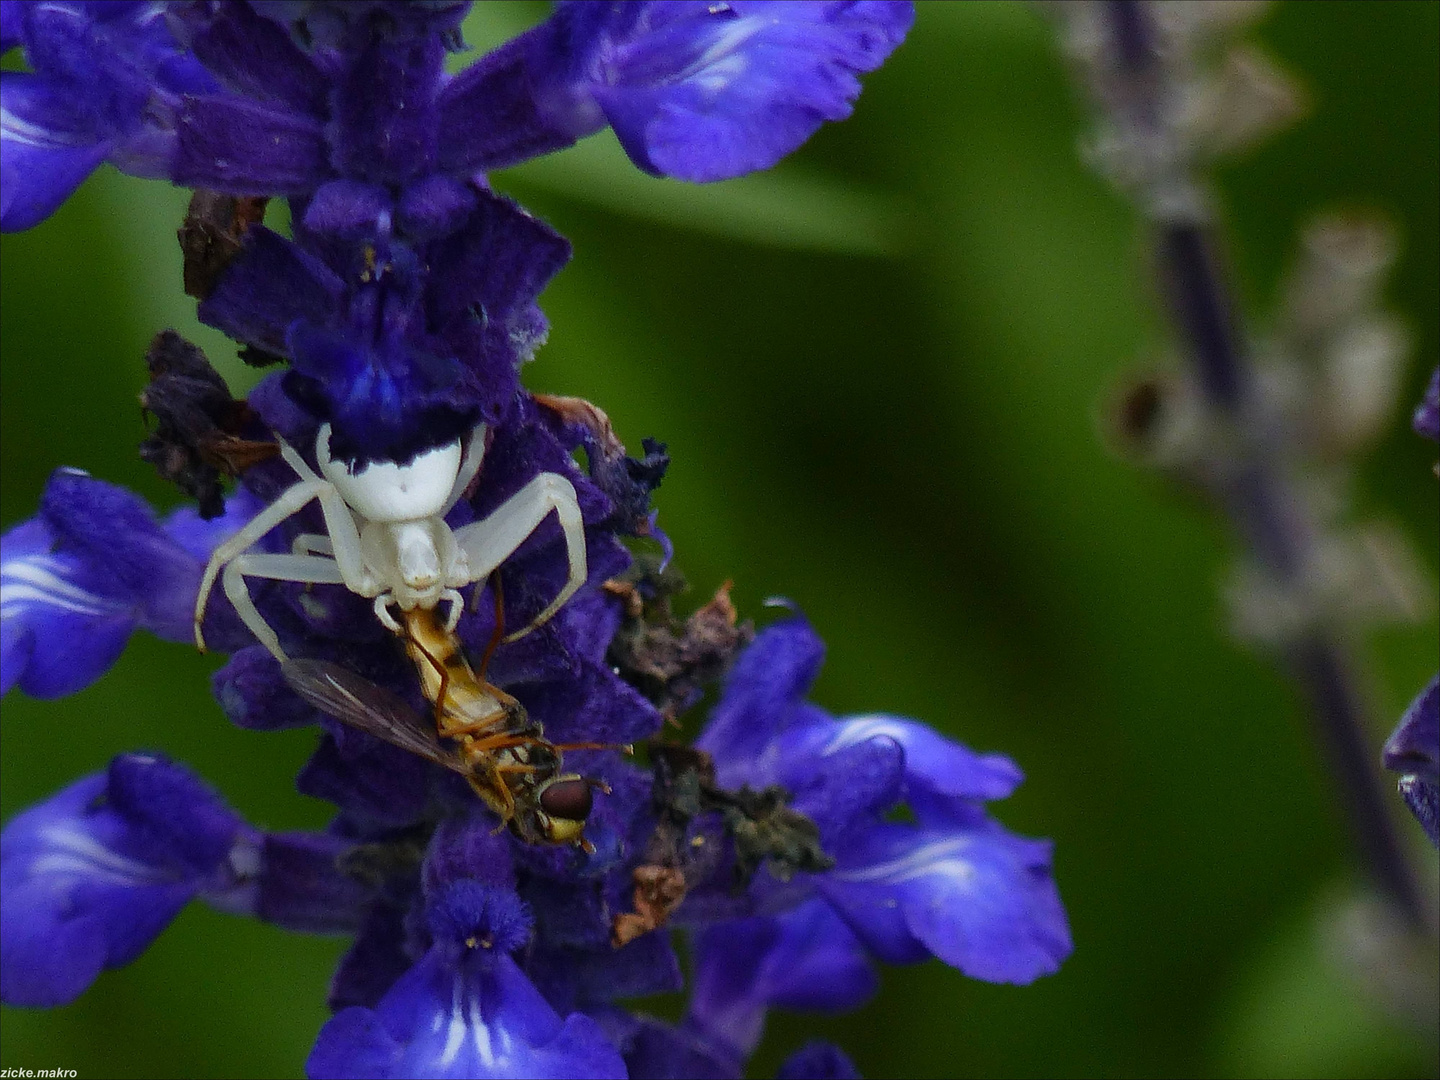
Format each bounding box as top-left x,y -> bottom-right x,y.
0,3 -> 1440,1076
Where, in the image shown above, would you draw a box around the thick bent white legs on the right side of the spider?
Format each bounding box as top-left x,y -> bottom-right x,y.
455,472 -> 588,642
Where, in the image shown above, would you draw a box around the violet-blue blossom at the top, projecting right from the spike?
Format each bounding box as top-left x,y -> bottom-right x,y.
439,0 -> 914,181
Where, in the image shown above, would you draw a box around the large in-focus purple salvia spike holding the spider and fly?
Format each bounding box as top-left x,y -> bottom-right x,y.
0,0 -> 1071,1077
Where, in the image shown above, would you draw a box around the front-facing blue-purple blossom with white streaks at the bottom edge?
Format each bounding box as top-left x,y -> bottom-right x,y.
305,880 -> 625,1080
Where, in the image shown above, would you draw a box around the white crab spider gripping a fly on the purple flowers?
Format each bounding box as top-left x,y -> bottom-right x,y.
194,423 -> 586,662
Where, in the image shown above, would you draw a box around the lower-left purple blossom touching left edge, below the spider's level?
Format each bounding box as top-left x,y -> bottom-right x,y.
0,755 -> 255,1007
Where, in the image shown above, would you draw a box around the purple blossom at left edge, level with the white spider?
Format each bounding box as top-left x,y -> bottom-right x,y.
0,469 -> 253,697
